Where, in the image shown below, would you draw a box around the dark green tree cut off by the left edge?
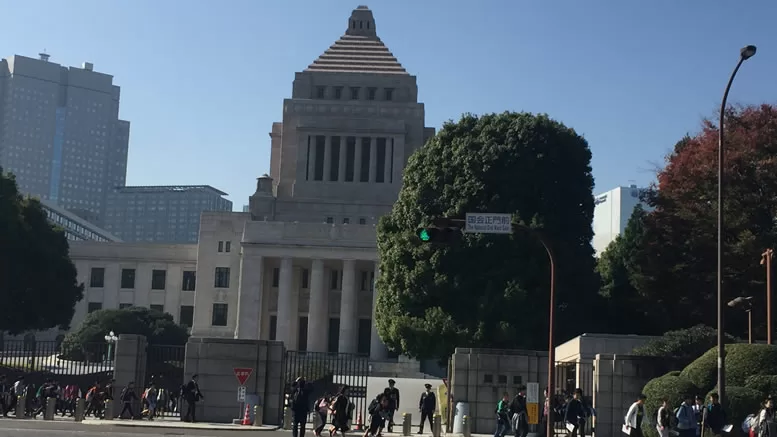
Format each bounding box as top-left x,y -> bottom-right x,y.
0,169 -> 84,334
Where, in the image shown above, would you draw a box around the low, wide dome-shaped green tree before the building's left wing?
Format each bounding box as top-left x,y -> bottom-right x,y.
62,307 -> 189,351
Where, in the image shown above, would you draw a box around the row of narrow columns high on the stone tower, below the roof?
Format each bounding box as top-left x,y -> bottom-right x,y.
308,135 -> 393,183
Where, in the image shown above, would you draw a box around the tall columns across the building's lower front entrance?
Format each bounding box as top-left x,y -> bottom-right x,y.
235,253 -> 388,360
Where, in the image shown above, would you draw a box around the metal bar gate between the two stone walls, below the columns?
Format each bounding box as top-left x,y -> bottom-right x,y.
280,351 -> 370,423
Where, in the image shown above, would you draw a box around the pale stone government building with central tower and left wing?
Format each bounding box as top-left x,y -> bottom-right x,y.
59,6 -> 434,360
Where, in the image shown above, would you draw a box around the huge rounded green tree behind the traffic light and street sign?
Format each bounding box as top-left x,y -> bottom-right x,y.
376,112 -> 598,358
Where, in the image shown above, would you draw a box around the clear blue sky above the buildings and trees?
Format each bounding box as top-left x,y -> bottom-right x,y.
0,0 -> 777,209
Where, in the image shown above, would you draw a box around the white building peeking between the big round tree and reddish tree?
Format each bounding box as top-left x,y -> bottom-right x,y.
592,185 -> 642,256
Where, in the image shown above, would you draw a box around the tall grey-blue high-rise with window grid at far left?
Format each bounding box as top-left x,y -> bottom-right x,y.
0,54 -> 129,225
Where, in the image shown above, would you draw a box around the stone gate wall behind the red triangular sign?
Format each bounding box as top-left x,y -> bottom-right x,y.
184,337 -> 285,425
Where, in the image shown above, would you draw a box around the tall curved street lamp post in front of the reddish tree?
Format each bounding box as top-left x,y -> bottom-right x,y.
717,46 -> 756,402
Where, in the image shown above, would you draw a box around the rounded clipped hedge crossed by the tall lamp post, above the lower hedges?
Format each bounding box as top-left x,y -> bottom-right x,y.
680,344 -> 777,392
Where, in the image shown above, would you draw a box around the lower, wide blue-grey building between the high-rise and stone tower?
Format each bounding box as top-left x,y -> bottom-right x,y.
105,185 -> 232,244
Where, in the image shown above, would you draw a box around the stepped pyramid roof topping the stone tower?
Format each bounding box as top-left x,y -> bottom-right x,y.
305,6 -> 409,76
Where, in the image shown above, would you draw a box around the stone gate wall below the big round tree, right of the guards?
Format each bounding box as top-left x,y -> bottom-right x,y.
450,348 -> 548,434
